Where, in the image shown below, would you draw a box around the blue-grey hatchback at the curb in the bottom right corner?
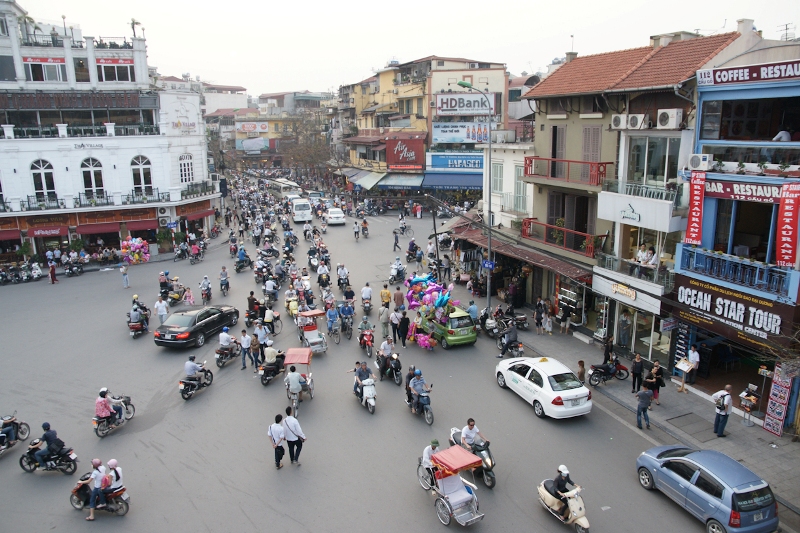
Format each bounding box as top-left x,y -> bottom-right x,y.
636,445 -> 778,533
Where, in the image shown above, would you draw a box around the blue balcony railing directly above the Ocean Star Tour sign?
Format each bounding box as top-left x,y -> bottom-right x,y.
679,244 -> 790,296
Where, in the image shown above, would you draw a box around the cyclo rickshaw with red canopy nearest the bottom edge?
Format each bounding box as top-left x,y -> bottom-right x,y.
417,446 -> 483,526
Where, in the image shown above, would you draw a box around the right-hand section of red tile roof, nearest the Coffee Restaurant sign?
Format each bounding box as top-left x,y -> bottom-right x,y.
612,32 -> 740,90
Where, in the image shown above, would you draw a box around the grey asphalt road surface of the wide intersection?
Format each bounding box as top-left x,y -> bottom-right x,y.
0,216 -> 704,533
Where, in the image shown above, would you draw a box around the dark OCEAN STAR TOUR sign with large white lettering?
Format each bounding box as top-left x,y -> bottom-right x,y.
673,274 -> 795,349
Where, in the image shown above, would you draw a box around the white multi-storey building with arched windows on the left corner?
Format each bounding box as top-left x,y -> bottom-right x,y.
0,0 -> 219,260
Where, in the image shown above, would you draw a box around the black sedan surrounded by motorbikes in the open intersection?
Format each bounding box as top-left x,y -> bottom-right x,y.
153,305 -> 239,348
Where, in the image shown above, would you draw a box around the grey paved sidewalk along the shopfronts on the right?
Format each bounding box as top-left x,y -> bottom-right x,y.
453,285 -> 800,514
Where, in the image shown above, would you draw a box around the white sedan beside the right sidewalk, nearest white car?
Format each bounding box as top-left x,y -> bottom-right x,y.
495,357 -> 592,418
